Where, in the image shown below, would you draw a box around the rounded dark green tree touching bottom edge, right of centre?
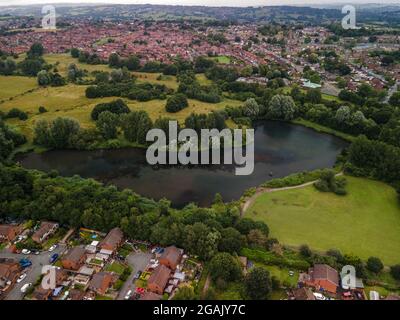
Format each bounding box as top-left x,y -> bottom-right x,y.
244,267 -> 272,300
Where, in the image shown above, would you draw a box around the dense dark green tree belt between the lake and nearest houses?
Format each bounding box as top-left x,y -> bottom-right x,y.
0,165 -> 268,262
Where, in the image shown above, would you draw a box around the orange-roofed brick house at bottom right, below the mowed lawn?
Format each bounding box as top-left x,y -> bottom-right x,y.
299,264 -> 339,294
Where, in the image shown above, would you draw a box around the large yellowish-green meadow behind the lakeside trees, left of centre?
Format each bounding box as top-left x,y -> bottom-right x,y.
0,79 -> 241,141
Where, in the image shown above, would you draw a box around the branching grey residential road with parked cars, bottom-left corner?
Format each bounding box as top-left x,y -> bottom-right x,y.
0,245 -> 66,300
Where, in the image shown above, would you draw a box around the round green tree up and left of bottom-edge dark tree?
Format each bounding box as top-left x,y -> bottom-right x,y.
209,252 -> 242,282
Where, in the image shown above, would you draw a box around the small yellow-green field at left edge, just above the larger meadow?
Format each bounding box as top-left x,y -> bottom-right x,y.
0,76 -> 38,100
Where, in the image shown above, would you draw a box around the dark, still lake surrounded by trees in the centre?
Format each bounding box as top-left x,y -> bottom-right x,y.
17,121 -> 348,207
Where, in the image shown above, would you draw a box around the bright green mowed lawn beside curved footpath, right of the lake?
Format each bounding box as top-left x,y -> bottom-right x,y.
246,177 -> 400,265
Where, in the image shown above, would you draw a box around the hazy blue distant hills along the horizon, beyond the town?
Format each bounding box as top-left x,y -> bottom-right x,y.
0,4 -> 400,25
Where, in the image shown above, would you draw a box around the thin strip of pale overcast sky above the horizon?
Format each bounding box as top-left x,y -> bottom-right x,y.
0,0 -> 400,6
